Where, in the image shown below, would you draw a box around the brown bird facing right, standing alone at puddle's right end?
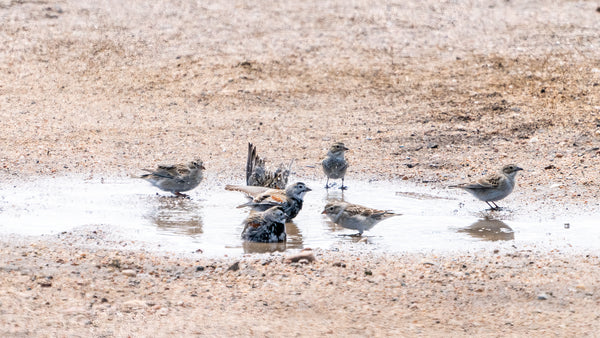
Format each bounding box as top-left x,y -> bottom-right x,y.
449,164 -> 523,210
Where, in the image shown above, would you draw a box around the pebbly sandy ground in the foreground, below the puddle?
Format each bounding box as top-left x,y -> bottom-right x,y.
0,231 -> 600,337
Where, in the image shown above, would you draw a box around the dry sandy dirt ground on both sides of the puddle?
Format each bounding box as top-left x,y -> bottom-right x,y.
0,0 -> 600,336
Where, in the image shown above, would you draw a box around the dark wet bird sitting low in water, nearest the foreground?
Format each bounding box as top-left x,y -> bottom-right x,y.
242,206 -> 287,243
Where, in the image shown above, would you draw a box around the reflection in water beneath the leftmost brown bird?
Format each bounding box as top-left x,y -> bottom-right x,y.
149,197 -> 203,236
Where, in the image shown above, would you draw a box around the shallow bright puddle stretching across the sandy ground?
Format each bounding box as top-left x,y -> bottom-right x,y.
0,177 -> 600,256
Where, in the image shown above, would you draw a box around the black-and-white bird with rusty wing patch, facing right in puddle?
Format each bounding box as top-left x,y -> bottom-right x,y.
225,182 -> 312,220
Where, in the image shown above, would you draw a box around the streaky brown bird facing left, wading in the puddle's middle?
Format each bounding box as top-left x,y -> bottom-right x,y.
321,201 -> 401,236
